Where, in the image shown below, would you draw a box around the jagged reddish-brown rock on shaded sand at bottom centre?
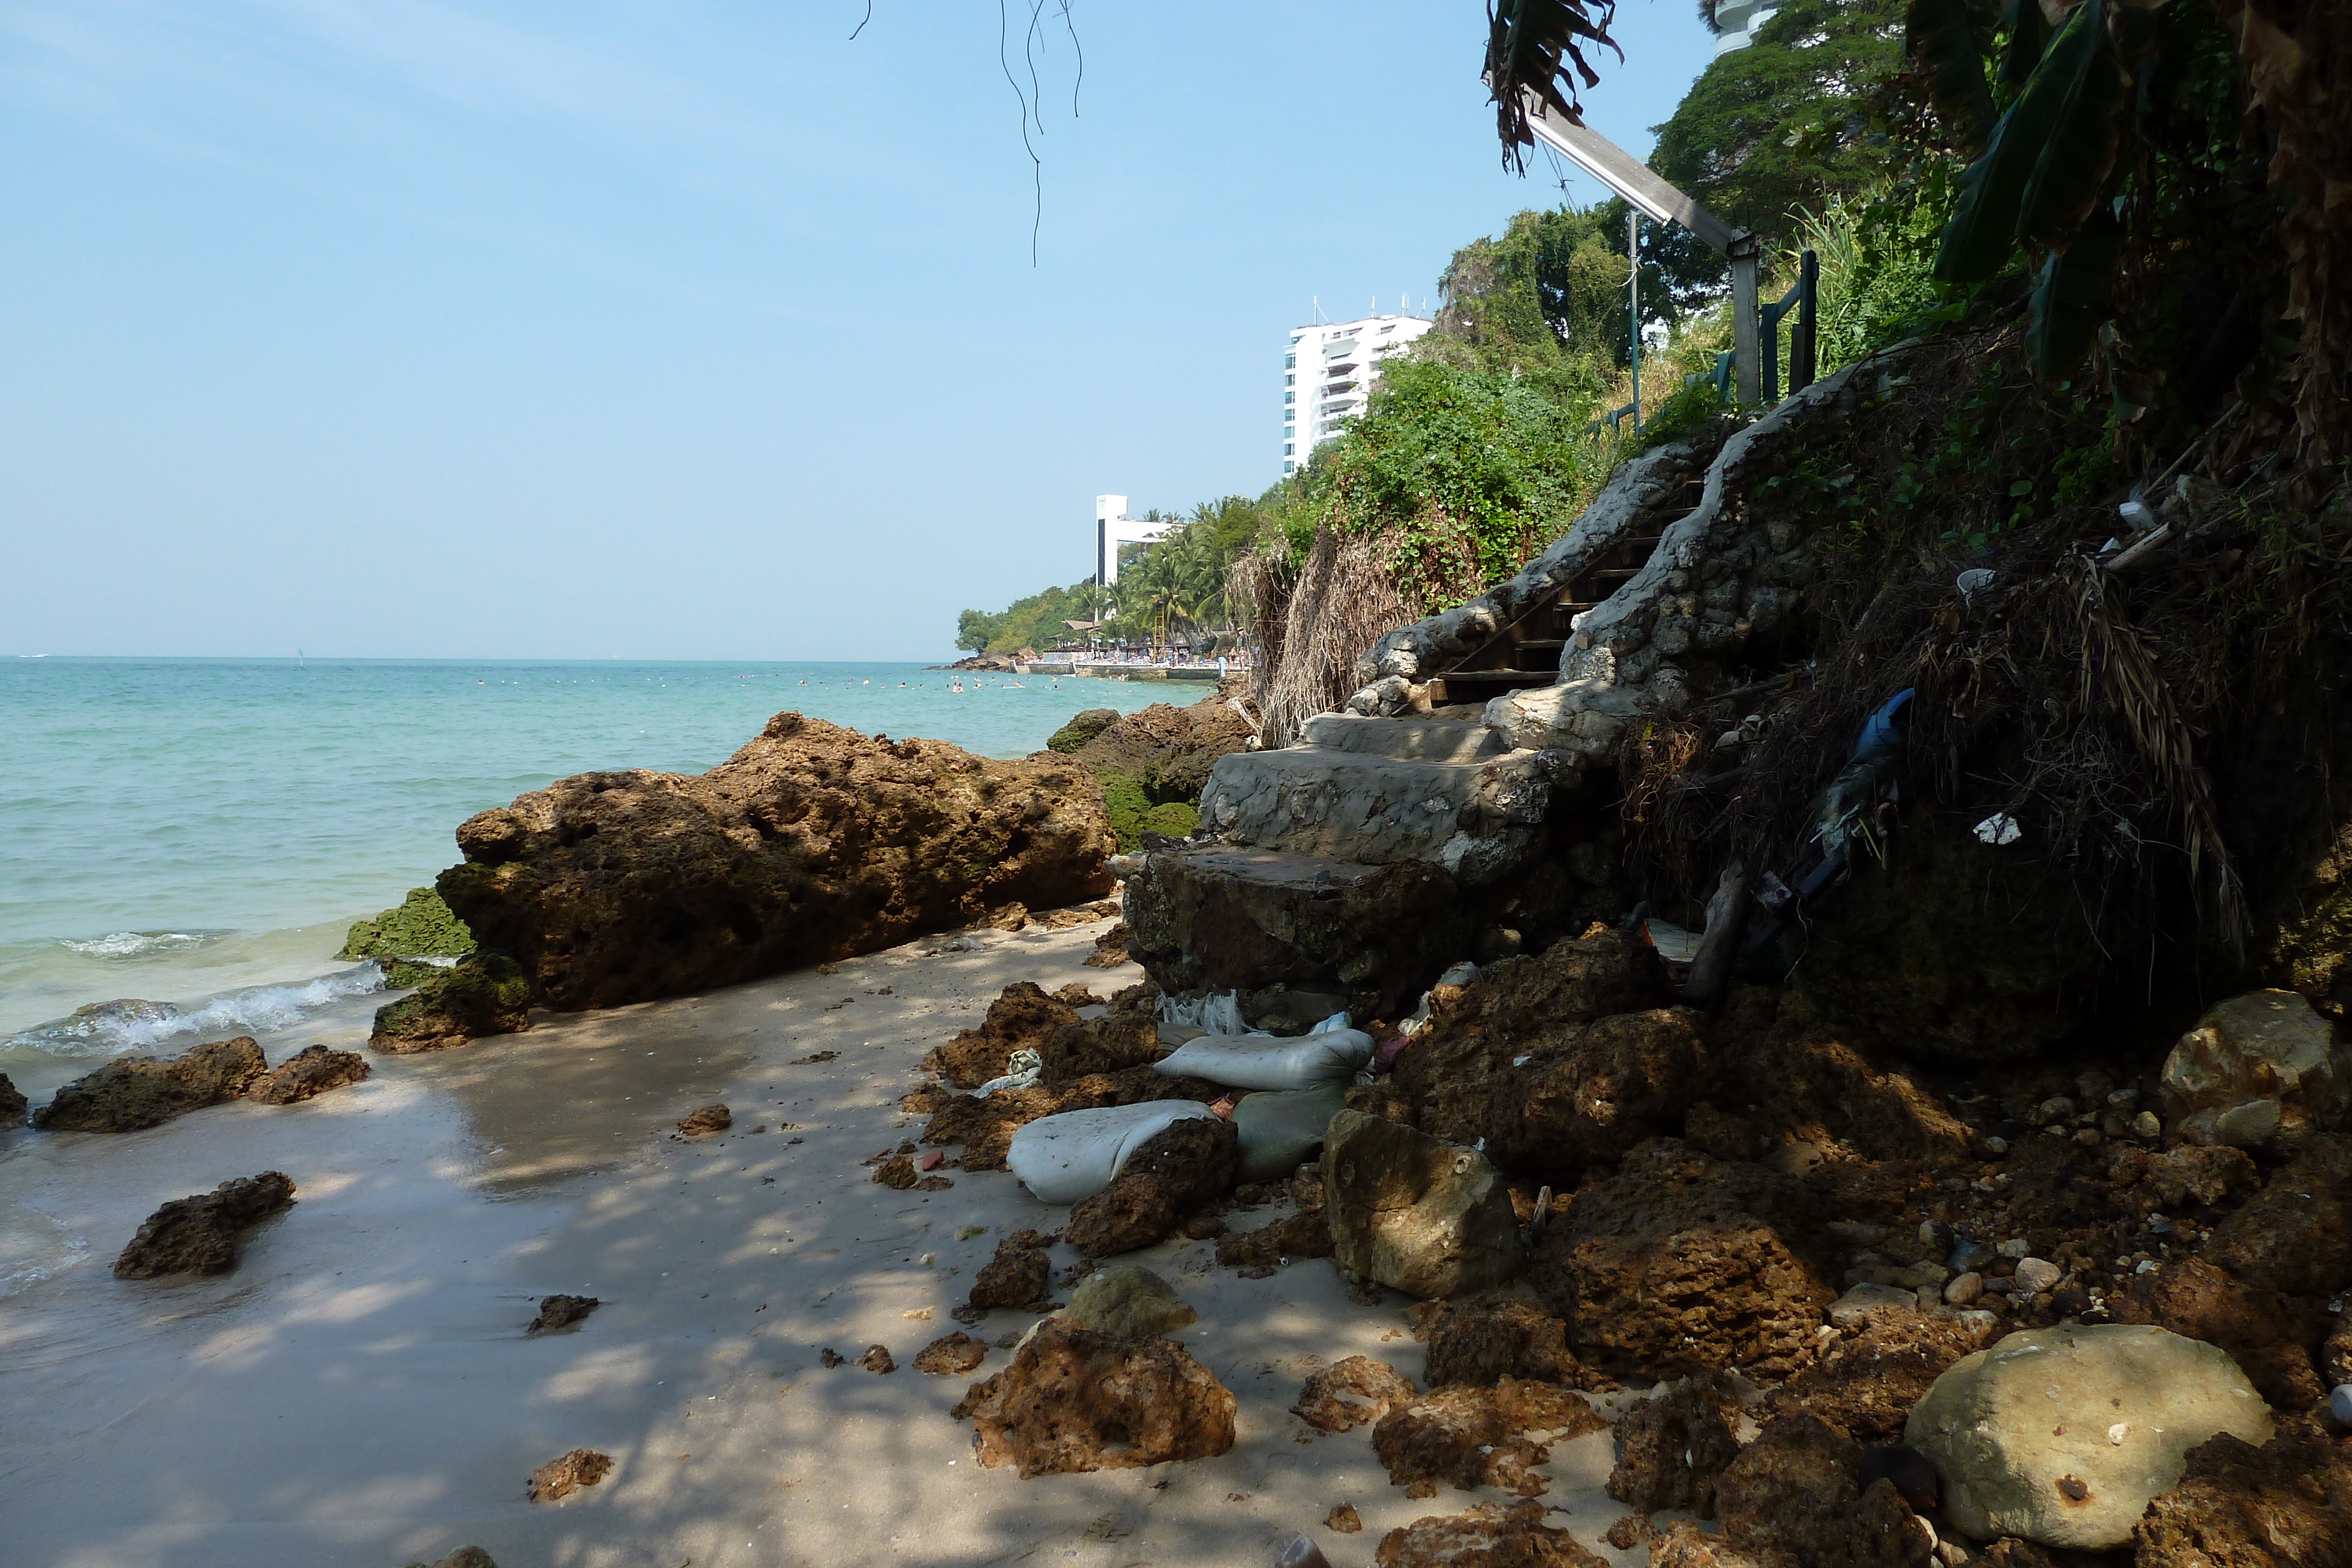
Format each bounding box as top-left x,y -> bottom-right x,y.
953,1319 -> 1235,1479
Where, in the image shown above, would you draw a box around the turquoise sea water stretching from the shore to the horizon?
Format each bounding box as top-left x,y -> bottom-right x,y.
0,658 -> 1176,1079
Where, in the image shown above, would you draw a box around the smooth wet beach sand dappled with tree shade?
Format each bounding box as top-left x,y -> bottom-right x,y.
0,924 -> 1646,1568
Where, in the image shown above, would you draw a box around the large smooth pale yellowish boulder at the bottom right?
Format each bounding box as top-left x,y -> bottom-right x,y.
1903,1323 -> 2270,1552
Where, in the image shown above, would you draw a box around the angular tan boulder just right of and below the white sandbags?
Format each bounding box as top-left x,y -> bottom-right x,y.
1322,1109 -> 1526,1298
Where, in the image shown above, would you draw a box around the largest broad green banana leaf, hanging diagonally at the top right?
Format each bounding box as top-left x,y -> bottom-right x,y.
1936,0 -> 2122,282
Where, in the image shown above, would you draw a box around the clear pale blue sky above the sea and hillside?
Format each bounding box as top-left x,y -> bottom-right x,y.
0,0 -> 1712,658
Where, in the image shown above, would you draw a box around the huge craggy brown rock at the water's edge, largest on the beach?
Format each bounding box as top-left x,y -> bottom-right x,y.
437,713 -> 1115,1008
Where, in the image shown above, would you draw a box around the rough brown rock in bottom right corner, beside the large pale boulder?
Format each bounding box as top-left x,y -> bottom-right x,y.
2131,1434 -> 2352,1568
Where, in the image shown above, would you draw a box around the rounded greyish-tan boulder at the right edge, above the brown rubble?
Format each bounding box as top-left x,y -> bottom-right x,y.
2159,989 -> 2352,1149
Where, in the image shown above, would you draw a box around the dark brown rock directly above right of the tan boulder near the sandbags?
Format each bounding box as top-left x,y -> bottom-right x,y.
1484,1006 -> 1715,1187
